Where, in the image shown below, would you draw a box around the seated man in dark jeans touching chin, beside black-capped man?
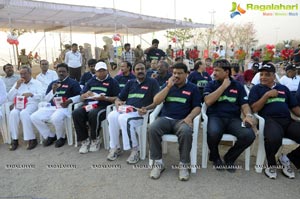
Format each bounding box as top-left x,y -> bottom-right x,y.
203,59 -> 255,172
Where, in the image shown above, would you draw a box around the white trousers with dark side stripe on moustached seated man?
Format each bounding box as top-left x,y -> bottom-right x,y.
107,111 -> 143,150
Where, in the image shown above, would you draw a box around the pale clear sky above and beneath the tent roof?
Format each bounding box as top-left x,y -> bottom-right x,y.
0,0 -> 300,64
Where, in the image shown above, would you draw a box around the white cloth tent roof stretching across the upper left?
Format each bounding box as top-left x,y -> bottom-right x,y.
0,0 -> 212,35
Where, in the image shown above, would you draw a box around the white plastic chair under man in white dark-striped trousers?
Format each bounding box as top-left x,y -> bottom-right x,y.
103,105 -> 152,160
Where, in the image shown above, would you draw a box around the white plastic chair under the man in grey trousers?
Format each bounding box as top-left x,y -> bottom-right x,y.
149,103 -> 200,173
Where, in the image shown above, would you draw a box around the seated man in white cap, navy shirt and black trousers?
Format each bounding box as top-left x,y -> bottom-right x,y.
72,62 -> 120,153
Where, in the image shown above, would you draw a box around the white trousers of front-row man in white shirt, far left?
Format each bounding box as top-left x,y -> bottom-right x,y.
9,103 -> 38,140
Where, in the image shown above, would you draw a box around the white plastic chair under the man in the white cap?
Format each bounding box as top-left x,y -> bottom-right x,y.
74,102 -> 113,149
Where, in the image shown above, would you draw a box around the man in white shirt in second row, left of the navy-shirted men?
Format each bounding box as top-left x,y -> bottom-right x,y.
36,59 -> 58,93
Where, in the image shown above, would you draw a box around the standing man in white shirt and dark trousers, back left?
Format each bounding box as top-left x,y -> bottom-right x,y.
65,43 -> 82,82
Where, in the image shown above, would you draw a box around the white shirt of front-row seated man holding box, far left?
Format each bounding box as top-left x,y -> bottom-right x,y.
7,78 -> 44,104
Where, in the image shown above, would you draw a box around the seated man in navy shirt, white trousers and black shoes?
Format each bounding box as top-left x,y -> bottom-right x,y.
30,63 -> 81,148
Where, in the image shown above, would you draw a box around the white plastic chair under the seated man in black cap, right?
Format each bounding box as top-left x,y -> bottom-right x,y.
254,113 -> 300,173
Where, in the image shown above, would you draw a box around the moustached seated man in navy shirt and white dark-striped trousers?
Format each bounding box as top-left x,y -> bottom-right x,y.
107,63 -> 159,164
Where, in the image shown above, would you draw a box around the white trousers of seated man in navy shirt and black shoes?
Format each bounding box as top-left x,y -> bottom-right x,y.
30,108 -> 71,139
